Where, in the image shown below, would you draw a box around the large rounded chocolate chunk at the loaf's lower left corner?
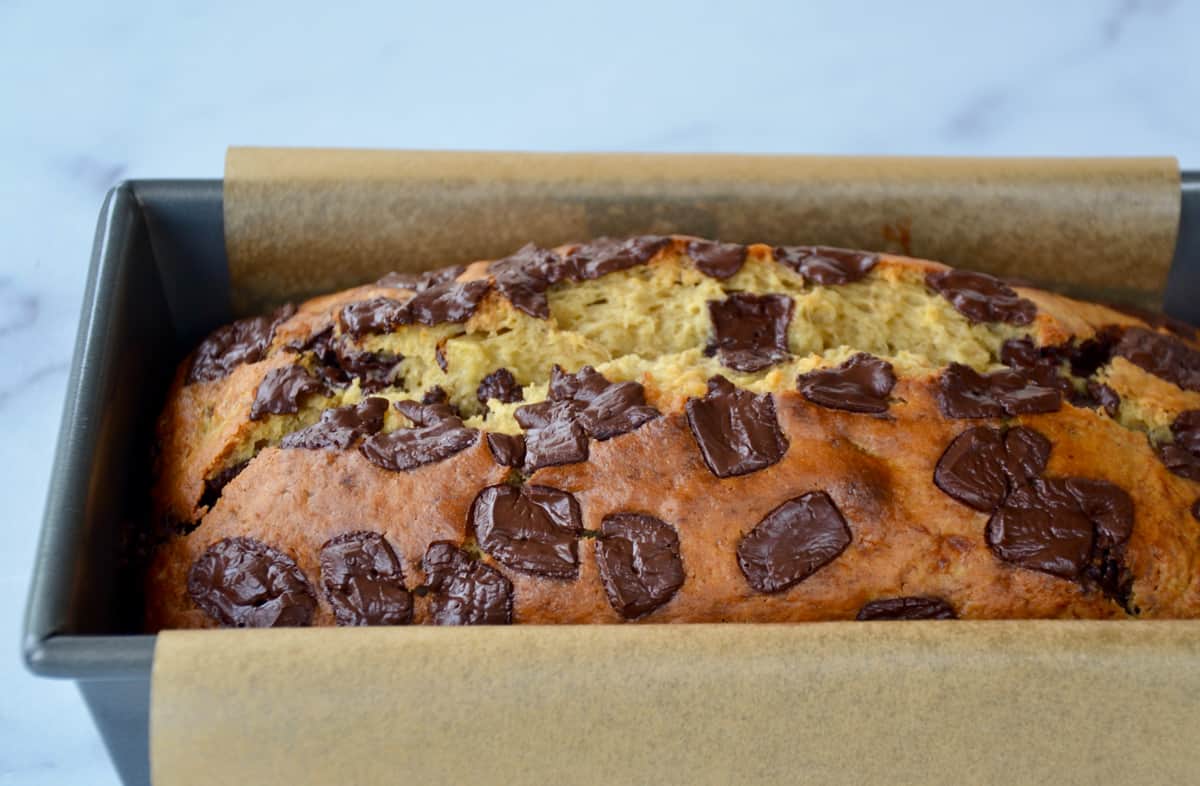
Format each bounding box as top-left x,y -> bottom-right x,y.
187,535 -> 317,628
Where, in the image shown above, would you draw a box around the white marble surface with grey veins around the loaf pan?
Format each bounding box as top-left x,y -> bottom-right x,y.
0,0 -> 1200,786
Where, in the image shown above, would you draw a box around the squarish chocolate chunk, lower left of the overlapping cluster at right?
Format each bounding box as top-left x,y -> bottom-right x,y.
984,479 -> 1096,580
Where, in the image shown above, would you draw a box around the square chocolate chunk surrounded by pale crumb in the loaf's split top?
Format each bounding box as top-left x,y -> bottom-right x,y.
708,293 -> 792,372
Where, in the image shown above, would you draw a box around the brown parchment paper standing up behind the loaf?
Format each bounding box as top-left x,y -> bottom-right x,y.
224,148 -> 1180,313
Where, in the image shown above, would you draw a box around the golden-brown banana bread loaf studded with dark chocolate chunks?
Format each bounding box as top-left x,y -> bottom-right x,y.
146,236 -> 1200,630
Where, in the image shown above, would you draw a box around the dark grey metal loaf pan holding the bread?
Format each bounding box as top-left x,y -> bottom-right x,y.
23,173 -> 1200,784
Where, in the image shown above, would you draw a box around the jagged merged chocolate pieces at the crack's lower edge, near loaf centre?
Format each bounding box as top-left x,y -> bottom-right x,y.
514,366 -> 659,472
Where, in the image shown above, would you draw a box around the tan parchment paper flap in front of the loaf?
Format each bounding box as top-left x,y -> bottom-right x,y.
151,620 -> 1200,786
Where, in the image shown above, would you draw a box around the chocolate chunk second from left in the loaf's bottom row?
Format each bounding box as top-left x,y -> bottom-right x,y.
320,532 -> 413,625
